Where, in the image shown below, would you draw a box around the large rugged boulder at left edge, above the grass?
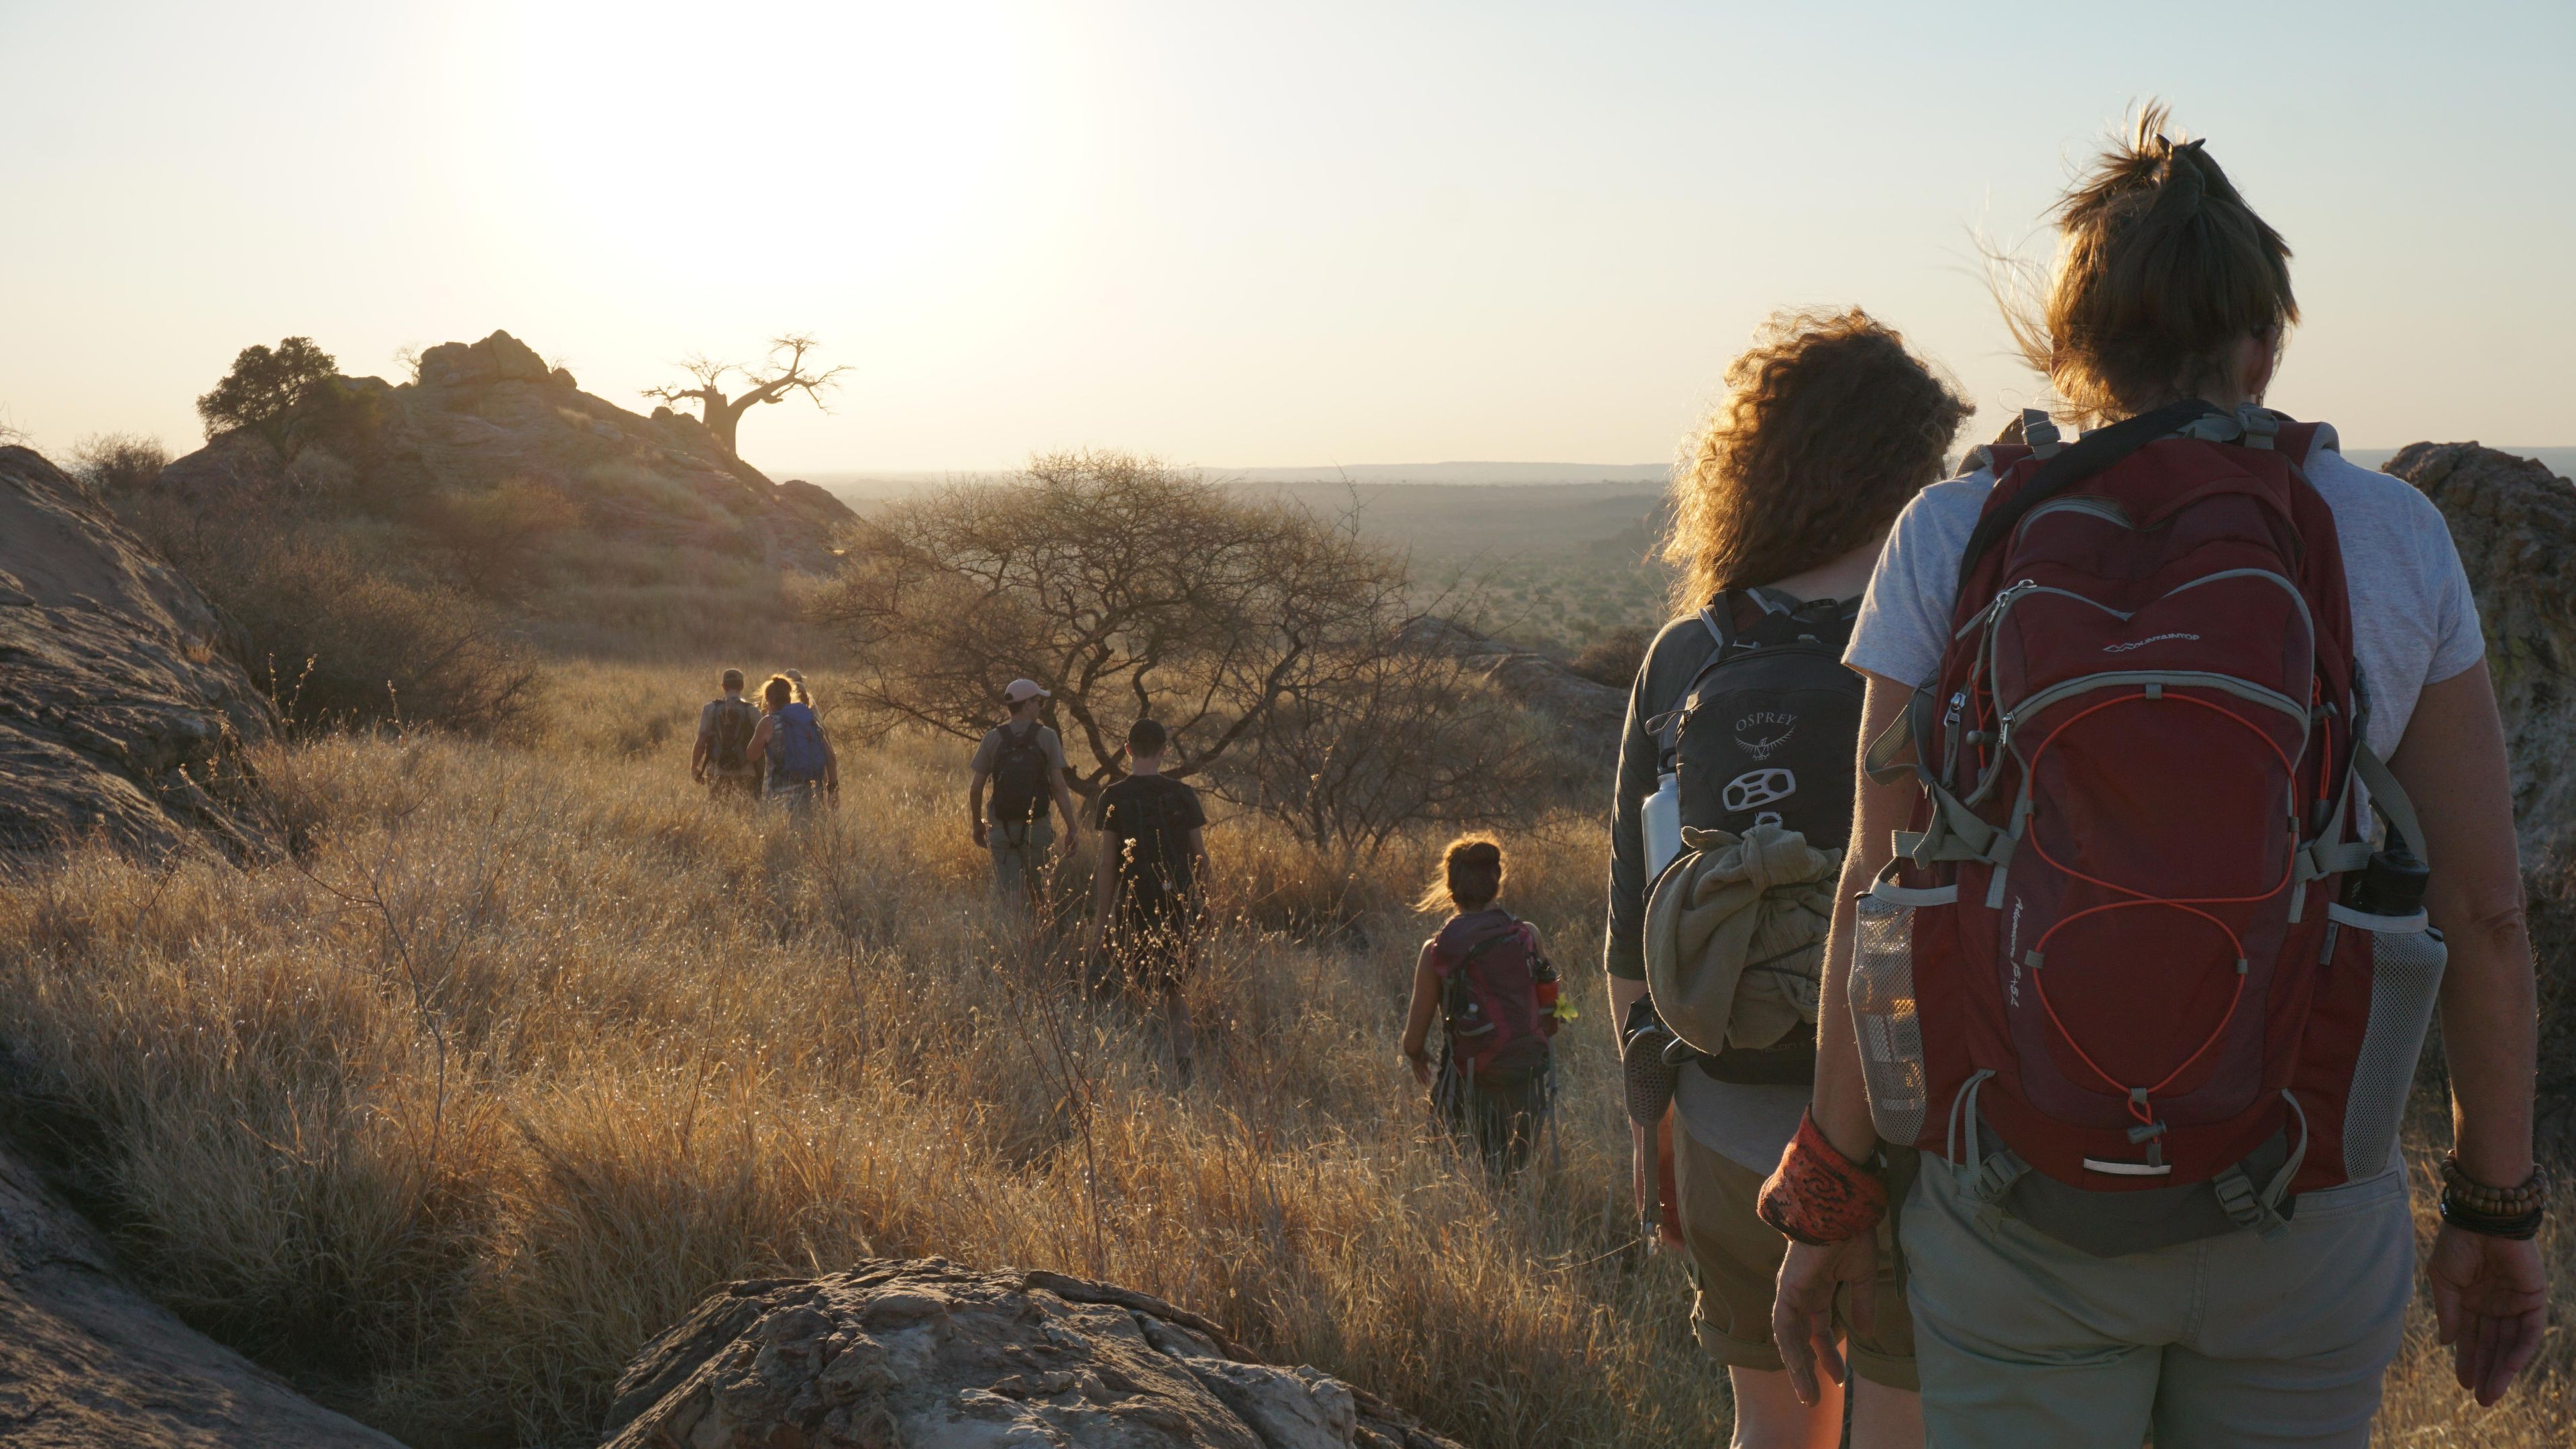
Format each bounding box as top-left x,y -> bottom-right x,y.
0,449 -> 273,856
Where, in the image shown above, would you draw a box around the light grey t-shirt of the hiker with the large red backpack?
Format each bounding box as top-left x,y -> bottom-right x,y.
1842,453 -> 2486,761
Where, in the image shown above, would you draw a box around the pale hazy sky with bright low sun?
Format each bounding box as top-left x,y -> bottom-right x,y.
0,0 -> 2576,474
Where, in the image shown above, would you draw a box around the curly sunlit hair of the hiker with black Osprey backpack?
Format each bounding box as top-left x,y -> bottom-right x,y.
1664,307 -> 1976,614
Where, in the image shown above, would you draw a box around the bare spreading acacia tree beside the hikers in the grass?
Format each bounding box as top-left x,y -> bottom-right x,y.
814,453 -> 1407,797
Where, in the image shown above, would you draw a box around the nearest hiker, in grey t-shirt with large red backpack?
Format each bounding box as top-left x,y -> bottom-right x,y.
1762,108 -> 2548,1449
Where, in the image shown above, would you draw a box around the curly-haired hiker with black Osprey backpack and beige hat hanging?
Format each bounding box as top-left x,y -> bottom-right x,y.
1605,309 -> 1968,1449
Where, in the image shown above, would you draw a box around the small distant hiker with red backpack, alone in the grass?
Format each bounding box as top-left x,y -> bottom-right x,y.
1401,835 -> 1558,1176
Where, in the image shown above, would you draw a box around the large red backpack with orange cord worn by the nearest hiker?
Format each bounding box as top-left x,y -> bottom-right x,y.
1852,402 -> 2442,1253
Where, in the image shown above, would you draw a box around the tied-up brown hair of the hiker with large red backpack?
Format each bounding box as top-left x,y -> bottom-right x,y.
1991,101 -> 2298,423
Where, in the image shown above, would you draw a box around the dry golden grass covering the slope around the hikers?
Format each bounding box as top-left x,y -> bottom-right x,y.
0,665 -> 2576,1446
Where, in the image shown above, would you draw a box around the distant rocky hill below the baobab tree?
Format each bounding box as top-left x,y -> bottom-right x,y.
162,333 -> 855,572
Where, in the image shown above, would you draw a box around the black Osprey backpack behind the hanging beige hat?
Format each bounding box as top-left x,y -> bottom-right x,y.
1646,588 -> 1865,1083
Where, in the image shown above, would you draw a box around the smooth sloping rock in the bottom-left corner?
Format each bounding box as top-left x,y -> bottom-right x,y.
0,1134 -> 402,1449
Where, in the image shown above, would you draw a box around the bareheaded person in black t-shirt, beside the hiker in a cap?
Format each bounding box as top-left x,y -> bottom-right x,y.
1092,719 -> 1208,1078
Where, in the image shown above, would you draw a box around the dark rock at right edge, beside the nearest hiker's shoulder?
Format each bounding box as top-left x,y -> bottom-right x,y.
2385,443 -> 2576,1163
